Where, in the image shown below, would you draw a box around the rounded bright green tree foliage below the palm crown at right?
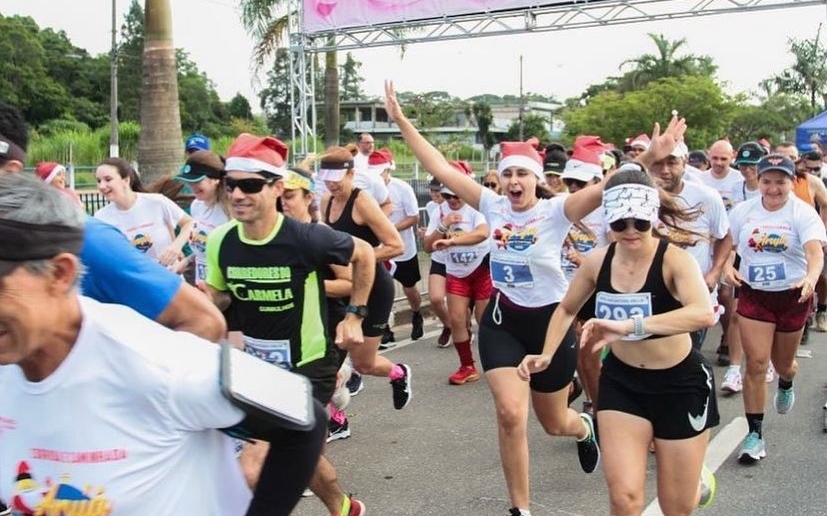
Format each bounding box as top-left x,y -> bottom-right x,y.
564,76 -> 734,148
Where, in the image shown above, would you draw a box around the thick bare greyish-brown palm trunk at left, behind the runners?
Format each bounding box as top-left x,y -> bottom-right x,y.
138,0 -> 184,184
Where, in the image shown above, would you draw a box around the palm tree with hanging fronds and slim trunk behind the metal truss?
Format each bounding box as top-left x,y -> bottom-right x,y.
240,0 -> 339,146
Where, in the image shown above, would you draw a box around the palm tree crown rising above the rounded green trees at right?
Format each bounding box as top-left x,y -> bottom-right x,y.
618,33 -> 717,91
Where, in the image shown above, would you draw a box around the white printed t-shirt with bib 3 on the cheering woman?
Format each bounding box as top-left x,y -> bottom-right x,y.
480,188 -> 571,307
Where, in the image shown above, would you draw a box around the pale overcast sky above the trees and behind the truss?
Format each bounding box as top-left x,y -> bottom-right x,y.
0,0 -> 827,109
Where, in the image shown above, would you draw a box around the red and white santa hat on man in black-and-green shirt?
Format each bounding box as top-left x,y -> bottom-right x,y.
224,133 -> 287,177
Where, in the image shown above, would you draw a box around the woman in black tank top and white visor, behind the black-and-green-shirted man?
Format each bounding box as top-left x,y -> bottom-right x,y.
318,147 -> 418,410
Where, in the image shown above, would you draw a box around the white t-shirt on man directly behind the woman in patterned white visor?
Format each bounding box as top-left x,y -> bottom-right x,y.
658,181 -> 729,274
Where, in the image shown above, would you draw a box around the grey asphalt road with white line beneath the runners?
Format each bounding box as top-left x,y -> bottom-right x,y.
294,320 -> 827,516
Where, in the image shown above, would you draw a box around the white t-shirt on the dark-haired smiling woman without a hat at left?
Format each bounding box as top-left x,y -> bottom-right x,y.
95,193 -> 187,260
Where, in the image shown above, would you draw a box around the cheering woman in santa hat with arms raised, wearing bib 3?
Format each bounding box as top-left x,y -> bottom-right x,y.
385,82 -> 686,516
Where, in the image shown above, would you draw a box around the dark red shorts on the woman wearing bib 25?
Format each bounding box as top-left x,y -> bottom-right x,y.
736,283 -> 813,332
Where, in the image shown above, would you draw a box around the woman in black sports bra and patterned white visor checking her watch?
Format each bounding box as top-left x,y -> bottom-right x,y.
518,164 -> 718,514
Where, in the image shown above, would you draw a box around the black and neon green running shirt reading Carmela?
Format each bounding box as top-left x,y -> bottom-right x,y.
206,214 -> 354,368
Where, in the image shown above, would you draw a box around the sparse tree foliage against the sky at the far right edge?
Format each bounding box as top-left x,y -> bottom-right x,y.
772,25 -> 827,116
